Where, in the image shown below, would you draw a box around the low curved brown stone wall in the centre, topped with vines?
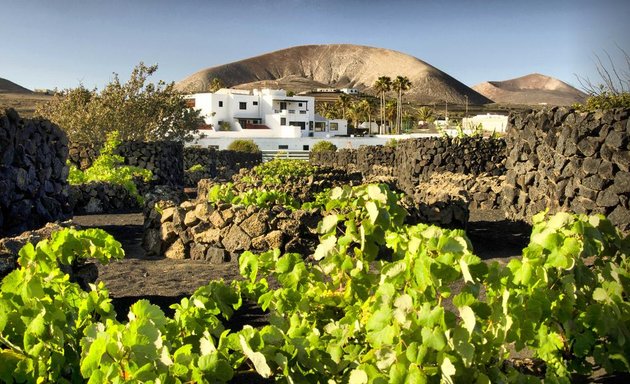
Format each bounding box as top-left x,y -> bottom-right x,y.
145,201 -> 319,263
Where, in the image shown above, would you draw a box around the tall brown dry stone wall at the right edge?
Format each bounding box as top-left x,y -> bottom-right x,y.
502,108 -> 630,231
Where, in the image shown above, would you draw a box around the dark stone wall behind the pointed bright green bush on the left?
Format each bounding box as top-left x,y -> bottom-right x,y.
69,141 -> 184,185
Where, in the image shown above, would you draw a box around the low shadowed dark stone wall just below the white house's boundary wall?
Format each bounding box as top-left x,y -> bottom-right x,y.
184,147 -> 262,187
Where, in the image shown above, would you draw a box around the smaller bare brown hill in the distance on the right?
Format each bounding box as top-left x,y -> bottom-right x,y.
473,73 -> 587,105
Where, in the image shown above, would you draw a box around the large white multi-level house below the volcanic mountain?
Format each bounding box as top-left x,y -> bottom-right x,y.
187,89 -> 348,139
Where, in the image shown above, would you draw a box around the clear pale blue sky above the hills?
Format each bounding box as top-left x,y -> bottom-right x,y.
0,0 -> 630,89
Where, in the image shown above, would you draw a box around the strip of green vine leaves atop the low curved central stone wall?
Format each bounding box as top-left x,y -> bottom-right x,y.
208,183 -> 300,209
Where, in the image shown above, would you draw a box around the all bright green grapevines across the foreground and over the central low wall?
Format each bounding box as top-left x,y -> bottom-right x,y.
0,178 -> 630,383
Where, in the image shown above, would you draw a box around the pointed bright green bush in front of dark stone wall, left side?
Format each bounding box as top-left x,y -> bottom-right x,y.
68,131 -> 153,204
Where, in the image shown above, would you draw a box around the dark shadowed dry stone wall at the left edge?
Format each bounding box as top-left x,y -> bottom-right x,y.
0,109 -> 70,237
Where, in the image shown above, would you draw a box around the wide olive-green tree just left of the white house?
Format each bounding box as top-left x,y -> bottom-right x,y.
37,63 -> 203,143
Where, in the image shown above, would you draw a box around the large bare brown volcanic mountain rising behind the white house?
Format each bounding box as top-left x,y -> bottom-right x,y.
176,44 -> 492,104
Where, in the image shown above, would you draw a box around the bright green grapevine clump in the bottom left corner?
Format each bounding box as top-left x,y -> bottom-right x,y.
0,229 -> 124,383
